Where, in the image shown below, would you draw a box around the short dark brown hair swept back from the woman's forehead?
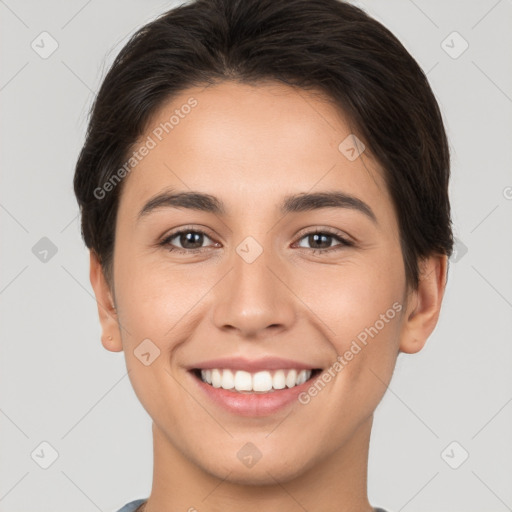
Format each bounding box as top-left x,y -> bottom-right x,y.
74,0 -> 453,288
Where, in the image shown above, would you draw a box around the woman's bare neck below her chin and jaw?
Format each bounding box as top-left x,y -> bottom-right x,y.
144,417 -> 373,512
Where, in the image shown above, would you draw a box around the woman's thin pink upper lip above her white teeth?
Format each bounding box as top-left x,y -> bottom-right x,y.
188,356 -> 319,372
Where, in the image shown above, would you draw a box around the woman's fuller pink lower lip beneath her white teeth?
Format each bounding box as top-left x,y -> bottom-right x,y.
188,372 -> 316,417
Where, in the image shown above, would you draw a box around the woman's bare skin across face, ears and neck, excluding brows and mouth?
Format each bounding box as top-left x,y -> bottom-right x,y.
90,82 -> 447,512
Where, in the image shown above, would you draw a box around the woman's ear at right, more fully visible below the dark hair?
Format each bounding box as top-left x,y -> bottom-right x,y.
400,255 -> 448,354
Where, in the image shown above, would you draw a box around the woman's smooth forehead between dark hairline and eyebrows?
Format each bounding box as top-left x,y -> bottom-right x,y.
120,82 -> 390,222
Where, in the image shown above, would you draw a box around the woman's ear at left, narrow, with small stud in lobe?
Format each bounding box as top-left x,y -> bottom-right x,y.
89,250 -> 123,352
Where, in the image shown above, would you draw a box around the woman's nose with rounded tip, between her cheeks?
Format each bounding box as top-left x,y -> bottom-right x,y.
213,245 -> 296,339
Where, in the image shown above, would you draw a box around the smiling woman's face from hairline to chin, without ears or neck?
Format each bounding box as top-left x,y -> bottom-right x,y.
91,82 -> 444,483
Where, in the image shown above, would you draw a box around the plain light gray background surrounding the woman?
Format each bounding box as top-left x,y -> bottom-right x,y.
0,0 -> 512,512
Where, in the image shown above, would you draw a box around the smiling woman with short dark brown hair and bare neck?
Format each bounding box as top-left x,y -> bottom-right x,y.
74,0 -> 453,512
